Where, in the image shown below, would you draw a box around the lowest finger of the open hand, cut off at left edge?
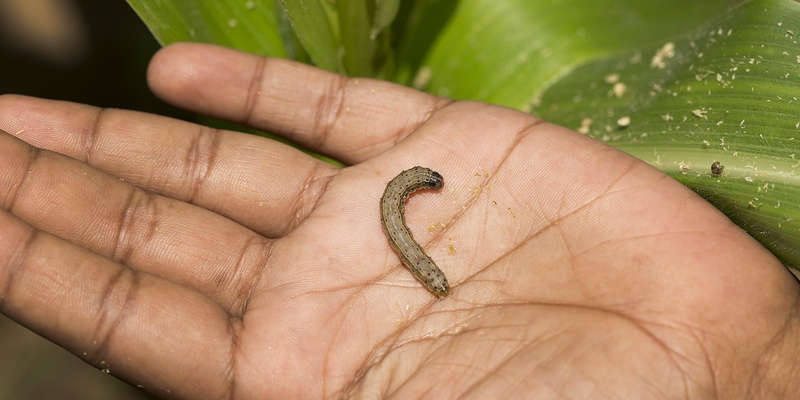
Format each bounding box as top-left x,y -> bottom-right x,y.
0,211 -> 234,398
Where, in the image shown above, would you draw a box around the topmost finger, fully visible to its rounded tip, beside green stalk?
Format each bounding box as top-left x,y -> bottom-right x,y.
148,43 -> 449,163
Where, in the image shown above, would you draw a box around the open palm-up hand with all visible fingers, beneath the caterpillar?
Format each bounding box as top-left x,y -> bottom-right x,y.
0,44 -> 800,399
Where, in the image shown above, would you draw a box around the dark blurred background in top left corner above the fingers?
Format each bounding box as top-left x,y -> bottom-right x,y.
0,0 -> 191,118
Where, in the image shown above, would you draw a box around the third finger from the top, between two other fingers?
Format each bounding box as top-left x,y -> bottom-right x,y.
0,131 -> 270,314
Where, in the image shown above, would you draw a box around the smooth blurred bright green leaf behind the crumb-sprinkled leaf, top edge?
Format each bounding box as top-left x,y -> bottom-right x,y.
412,0 -> 738,110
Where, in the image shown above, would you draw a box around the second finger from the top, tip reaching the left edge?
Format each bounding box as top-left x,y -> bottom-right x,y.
0,96 -> 337,237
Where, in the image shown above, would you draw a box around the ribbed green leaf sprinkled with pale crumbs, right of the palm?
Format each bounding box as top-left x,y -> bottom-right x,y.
535,0 -> 800,267
